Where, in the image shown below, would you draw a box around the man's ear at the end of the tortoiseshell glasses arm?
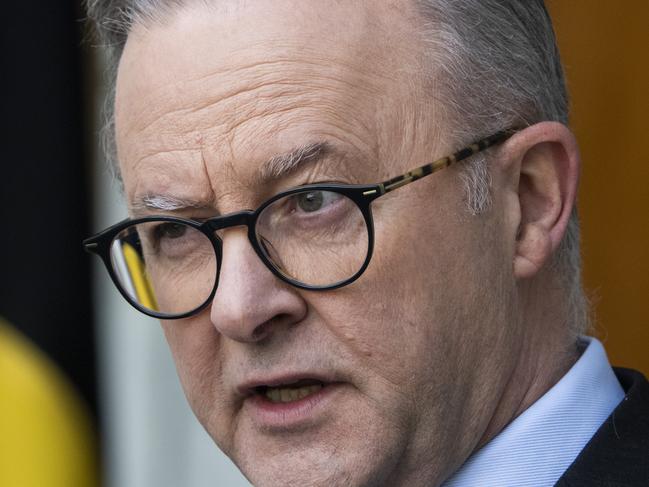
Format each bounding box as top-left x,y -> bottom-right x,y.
509,122 -> 580,279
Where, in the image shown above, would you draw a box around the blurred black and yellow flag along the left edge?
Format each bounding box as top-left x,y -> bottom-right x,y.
0,0 -> 99,487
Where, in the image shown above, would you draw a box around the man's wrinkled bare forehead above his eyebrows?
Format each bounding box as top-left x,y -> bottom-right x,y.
116,0 -> 430,210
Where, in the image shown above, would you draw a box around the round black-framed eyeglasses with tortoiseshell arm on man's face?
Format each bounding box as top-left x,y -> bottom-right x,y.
83,130 -> 515,319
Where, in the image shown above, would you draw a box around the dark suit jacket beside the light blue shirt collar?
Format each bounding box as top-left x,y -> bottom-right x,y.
555,368 -> 649,487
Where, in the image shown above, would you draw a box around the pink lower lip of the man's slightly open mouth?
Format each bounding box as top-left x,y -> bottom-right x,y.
246,383 -> 342,430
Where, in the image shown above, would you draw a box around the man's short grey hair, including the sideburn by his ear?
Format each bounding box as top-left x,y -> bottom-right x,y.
86,0 -> 589,337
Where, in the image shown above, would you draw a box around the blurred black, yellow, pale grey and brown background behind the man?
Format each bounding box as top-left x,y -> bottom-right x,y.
0,0 -> 649,487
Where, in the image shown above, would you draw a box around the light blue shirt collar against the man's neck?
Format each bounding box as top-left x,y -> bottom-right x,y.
442,337 -> 624,487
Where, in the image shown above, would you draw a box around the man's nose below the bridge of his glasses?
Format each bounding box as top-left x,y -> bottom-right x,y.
210,229 -> 307,342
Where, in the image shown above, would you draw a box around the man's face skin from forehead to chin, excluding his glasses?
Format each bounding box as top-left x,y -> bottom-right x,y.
116,0 -> 518,486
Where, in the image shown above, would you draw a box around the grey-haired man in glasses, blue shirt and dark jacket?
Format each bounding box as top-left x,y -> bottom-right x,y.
86,0 -> 649,486
